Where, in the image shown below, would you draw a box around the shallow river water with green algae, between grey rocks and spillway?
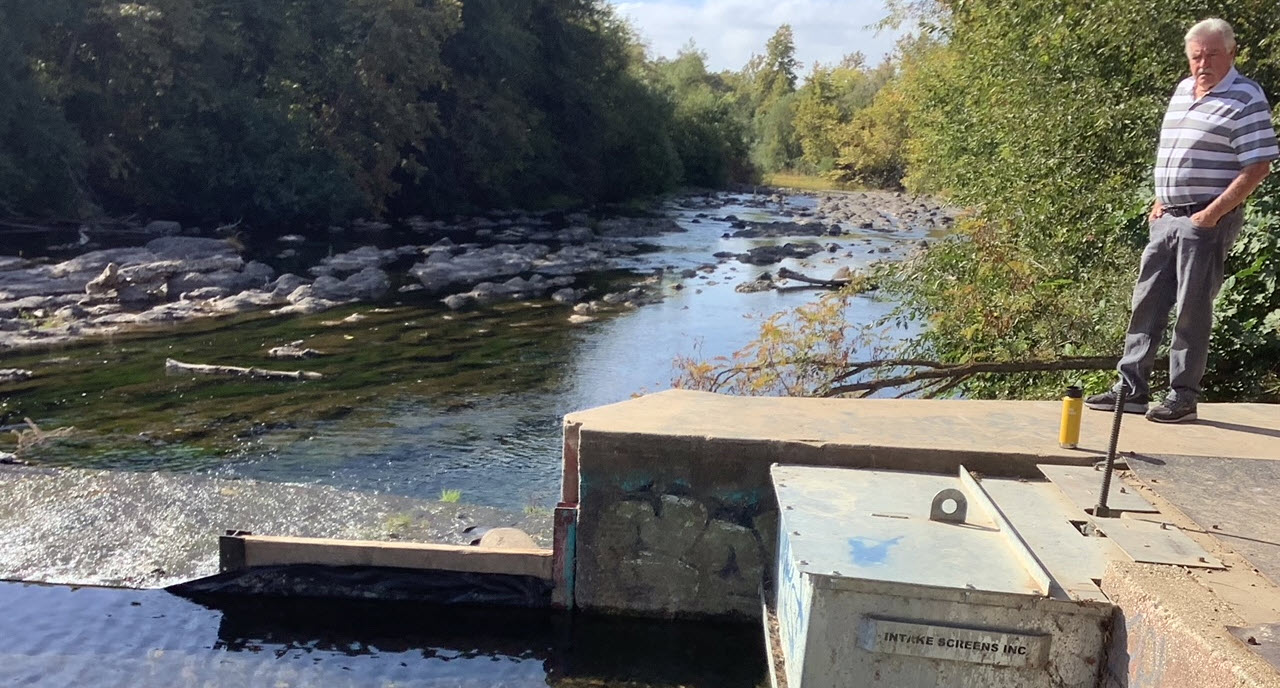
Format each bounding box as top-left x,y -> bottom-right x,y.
0,197 -> 925,508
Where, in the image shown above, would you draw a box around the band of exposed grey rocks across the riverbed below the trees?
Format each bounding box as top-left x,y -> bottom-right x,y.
0,192 -> 956,350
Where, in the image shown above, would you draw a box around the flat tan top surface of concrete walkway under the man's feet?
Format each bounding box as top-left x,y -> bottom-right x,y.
566,390 -> 1280,463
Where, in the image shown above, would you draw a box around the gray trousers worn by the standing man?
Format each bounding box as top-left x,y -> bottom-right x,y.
1119,207 -> 1244,402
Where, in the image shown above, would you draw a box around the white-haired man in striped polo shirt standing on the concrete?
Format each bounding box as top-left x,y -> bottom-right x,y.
1085,19 -> 1280,423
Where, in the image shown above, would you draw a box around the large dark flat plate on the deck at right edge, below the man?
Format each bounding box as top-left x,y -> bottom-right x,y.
1129,455 -> 1280,583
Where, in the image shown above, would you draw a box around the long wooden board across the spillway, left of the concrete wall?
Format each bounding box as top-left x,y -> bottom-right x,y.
243,535 -> 552,581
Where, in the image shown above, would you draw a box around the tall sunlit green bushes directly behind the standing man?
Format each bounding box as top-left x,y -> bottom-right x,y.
888,0 -> 1280,399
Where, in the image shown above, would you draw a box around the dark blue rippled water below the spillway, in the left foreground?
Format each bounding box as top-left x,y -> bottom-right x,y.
0,583 -> 764,688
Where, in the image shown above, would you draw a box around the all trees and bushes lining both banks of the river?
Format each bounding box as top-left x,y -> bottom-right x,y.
0,0 -> 1280,400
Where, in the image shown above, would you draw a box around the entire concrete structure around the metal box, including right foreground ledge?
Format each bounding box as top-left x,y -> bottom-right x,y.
556,391 -> 1280,688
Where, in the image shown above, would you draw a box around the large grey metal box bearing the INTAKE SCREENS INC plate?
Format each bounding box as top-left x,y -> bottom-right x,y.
772,465 -> 1112,688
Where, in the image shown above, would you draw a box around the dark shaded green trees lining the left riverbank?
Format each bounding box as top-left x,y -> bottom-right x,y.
0,0 -> 721,226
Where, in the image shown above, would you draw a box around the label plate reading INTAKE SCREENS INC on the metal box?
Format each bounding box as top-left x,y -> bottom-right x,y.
858,616 -> 1050,668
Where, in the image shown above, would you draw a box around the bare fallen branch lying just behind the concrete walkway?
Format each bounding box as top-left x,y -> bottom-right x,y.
823,357 -> 1120,396
